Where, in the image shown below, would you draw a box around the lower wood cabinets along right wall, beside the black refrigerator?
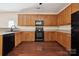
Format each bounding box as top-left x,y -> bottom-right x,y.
56,32 -> 71,51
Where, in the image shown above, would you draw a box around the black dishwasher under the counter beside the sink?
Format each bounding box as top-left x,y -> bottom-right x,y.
3,33 -> 15,56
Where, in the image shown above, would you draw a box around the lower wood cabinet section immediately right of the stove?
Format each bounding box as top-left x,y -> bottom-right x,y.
44,31 -> 57,41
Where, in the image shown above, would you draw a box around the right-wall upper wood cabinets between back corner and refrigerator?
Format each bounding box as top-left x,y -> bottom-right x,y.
57,5 -> 71,26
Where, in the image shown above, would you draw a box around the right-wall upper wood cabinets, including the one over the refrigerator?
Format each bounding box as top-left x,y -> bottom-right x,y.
57,3 -> 79,26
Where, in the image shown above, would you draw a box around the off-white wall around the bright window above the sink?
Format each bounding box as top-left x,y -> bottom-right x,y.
0,13 -> 17,28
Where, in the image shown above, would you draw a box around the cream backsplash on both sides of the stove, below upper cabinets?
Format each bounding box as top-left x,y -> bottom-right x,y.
18,25 -> 71,33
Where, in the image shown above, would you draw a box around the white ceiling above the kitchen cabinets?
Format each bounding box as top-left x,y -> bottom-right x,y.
0,3 -> 69,14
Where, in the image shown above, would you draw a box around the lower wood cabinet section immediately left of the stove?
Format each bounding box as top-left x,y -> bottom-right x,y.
22,32 -> 35,41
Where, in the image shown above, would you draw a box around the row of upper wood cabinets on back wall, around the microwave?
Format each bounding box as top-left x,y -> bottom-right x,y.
18,14 -> 57,26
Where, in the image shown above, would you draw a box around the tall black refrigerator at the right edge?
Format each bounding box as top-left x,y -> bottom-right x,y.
71,11 -> 79,56
